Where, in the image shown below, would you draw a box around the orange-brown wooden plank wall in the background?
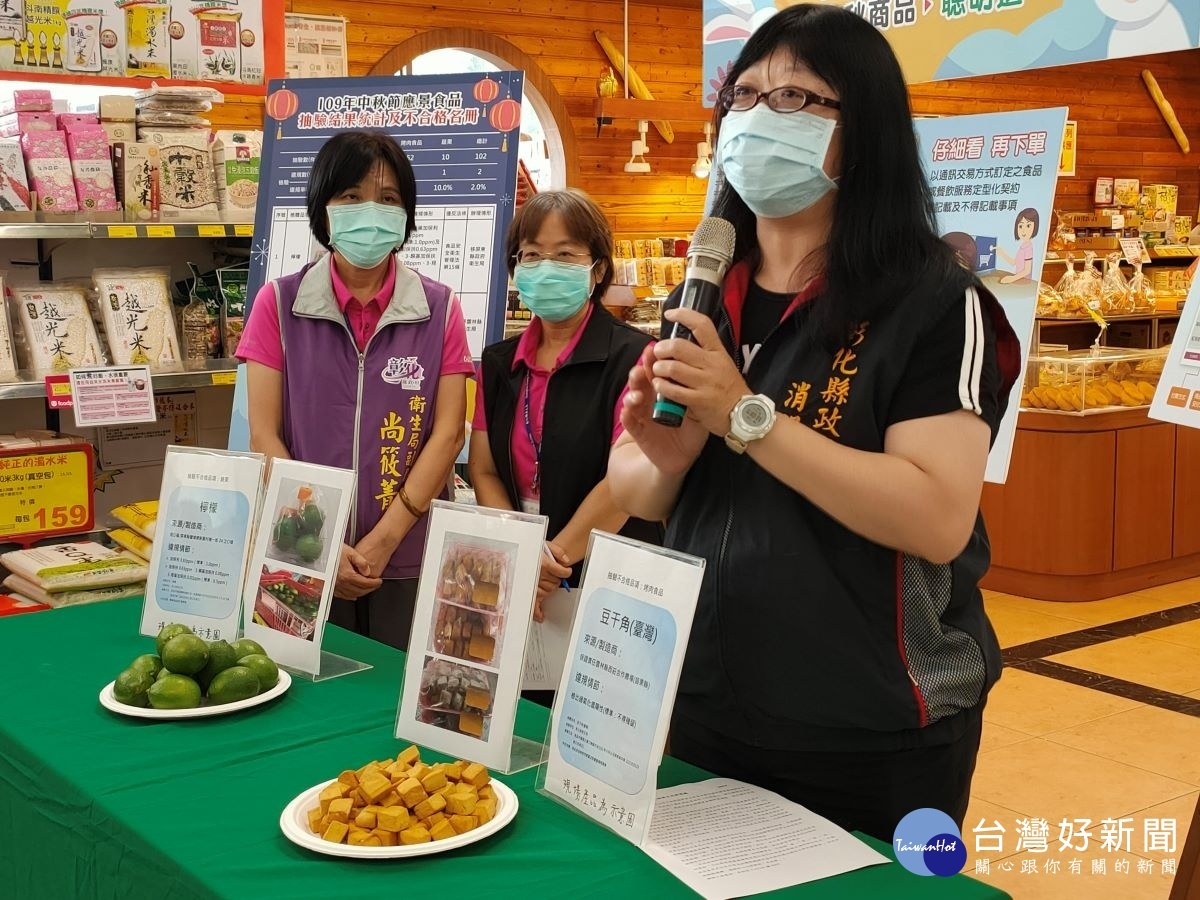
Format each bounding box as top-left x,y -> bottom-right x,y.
215,0 -> 1200,238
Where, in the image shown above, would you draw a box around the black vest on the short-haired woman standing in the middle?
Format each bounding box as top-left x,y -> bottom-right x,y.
482,306 -> 662,587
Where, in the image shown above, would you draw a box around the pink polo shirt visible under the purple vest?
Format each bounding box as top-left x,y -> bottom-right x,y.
238,257 -> 475,374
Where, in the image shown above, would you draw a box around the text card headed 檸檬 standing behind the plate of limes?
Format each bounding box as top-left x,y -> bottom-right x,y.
142,446 -> 263,642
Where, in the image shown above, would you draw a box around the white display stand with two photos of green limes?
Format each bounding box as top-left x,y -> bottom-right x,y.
242,460 -> 360,680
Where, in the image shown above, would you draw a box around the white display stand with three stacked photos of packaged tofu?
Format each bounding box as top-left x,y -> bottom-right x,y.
396,500 -> 546,774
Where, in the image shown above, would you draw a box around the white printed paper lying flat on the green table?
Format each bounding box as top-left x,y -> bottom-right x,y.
642,778 -> 890,900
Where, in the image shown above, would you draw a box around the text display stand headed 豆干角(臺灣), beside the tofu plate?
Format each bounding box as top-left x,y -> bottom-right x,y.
535,532 -> 704,846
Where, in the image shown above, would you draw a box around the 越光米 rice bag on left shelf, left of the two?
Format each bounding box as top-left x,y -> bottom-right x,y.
10,282 -> 108,378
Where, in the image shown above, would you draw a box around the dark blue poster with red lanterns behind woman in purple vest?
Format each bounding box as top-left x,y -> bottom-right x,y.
248,71 -> 524,359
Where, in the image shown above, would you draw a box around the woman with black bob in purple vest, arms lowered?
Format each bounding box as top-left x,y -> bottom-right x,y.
238,131 -> 474,649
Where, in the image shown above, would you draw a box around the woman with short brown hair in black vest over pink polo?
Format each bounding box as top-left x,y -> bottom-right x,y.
468,191 -> 662,657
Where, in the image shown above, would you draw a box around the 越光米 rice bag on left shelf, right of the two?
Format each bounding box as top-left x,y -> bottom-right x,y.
92,269 -> 182,370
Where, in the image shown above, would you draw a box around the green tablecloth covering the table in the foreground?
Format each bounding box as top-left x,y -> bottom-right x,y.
0,600 -> 1004,900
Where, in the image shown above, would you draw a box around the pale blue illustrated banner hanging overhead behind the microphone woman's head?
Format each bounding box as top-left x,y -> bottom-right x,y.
703,0 -> 1200,95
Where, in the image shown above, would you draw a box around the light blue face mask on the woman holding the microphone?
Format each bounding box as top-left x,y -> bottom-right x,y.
716,103 -> 838,218
